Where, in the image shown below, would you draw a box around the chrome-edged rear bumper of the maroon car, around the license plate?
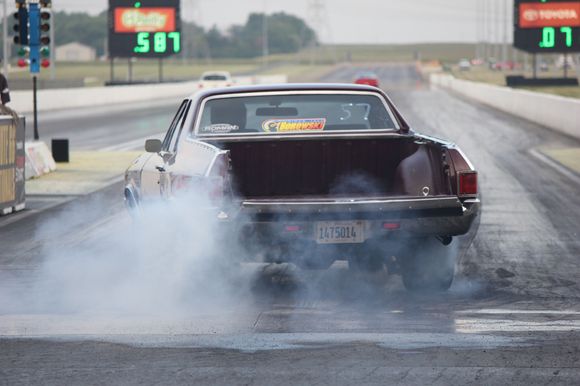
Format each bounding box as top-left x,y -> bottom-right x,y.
228,197 -> 481,240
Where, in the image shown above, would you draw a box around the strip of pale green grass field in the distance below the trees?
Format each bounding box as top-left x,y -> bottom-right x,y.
9,44 -> 474,86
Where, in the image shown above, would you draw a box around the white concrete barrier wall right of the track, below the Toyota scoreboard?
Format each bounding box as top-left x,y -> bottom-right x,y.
430,74 -> 580,139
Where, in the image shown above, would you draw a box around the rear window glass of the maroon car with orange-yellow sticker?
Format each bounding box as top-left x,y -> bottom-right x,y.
196,94 -> 398,135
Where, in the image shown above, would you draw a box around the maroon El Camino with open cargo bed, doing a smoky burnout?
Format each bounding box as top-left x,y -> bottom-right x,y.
124,84 -> 480,290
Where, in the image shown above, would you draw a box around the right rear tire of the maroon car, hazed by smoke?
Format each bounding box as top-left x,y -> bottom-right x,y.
400,238 -> 456,292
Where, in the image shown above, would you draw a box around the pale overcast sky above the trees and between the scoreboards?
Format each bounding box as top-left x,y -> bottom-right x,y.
53,0 -> 512,43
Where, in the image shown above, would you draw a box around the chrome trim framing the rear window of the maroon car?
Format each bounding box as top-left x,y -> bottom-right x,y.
193,90 -> 401,139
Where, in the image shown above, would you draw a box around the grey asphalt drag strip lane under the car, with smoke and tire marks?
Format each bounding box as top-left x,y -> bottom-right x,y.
0,64 -> 580,385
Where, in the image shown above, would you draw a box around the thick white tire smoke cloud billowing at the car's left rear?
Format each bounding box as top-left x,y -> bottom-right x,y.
0,186 -> 254,315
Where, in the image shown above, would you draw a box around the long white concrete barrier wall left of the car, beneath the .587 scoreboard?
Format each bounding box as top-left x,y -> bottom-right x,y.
10,75 -> 288,114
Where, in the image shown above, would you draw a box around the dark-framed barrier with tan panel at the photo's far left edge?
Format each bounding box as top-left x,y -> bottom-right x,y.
0,115 -> 26,215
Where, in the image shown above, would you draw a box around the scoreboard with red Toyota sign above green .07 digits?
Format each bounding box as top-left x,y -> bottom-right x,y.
514,0 -> 580,53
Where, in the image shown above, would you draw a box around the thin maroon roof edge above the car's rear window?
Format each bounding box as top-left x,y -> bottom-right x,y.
190,83 -> 382,99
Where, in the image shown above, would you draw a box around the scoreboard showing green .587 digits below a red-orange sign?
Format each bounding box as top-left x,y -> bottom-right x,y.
109,0 -> 181,58
